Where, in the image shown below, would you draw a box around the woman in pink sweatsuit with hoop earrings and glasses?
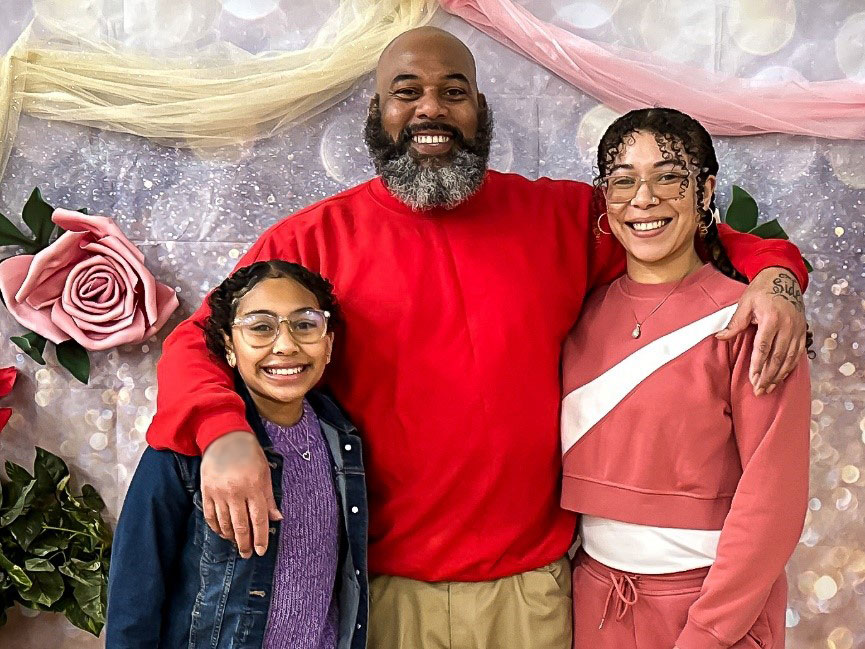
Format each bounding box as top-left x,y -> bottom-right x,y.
562,108 -> 810,649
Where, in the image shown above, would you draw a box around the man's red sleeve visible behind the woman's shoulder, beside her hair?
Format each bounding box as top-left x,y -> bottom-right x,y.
718,223 -> 808,291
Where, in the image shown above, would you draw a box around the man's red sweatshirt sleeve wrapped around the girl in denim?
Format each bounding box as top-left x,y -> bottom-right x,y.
147,224 -> 298,455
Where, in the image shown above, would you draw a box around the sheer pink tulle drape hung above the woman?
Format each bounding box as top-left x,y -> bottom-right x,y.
440,0 -> 865,140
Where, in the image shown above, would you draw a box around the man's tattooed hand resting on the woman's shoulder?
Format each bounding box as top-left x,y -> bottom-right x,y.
718,268 -> 807,395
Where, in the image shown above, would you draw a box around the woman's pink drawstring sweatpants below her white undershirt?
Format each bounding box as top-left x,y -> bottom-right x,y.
573,550 -> 787,649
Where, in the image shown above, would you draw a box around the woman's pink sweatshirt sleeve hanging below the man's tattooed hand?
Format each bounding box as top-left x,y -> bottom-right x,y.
676,327 -> 811,649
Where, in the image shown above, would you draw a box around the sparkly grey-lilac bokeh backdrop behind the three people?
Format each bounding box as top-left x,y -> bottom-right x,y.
0,0 -> 865,649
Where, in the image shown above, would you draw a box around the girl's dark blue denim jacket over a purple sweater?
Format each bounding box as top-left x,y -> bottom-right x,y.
105,385 -> 368,649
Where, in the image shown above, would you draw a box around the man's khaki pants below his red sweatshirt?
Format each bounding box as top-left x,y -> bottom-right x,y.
368,557 -> 573,649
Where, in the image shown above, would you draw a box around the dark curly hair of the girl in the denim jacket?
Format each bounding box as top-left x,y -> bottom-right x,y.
203,259 -> 340,358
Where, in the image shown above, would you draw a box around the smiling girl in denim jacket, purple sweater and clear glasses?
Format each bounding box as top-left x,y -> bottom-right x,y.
106,261 -> 367,649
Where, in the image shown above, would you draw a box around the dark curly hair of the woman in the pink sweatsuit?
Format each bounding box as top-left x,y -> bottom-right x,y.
594,108 -> 813,356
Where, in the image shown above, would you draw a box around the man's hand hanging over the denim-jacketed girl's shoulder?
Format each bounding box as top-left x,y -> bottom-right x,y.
201,431 -> 282,559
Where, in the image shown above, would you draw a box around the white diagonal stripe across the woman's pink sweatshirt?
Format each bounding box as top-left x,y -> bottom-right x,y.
562,304 -> 736,455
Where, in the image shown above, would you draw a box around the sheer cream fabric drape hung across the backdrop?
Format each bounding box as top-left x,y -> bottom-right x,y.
0,0 -> 438,182
